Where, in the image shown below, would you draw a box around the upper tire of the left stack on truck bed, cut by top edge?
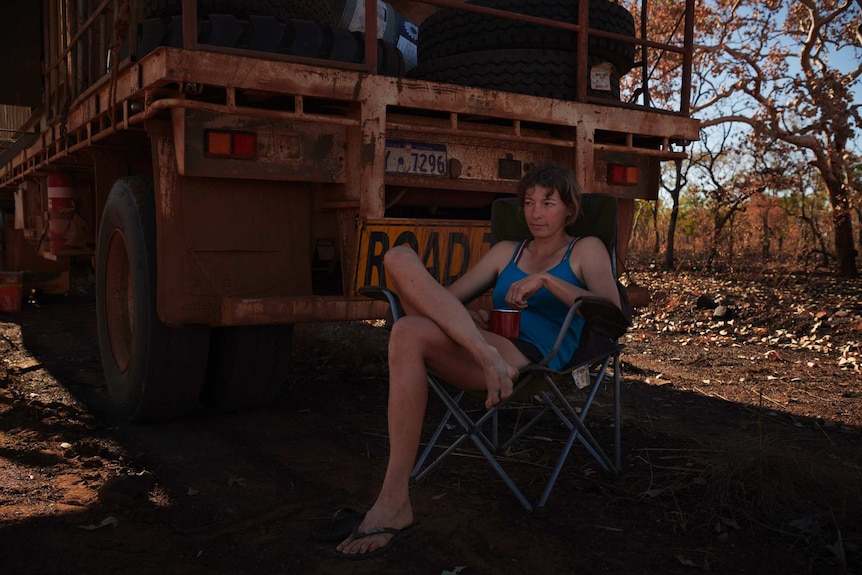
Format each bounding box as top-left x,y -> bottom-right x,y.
143,0 -> 334,24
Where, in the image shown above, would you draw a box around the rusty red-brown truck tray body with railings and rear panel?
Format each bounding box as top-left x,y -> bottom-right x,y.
0,0 -> 699,325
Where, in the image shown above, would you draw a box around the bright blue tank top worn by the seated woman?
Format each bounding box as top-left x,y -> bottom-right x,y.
492,238 -> 586,370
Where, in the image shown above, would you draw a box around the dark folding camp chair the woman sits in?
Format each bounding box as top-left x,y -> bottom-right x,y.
360,194 -> 631,512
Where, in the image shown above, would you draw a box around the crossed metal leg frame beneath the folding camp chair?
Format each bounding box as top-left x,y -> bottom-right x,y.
411,352 -> 622,512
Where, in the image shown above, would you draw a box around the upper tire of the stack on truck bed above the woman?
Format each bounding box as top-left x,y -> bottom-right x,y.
417,0 -> 635,75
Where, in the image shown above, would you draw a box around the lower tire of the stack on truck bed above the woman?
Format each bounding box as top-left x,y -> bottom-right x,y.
409,49 -> 620,100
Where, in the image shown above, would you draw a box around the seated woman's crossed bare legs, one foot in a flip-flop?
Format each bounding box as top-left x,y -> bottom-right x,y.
337,250 -> 527,554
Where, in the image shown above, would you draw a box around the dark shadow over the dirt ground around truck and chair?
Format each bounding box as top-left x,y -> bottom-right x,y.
0,308 -> 862,575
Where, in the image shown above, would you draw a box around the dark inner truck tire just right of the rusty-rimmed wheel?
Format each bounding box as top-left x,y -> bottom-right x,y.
201,325 -> 293,412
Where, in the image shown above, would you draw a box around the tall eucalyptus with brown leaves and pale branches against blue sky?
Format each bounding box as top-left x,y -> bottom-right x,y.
694,0 -> 862,277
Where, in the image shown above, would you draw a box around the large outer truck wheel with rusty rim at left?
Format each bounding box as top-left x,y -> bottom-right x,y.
96,176 -> 209,421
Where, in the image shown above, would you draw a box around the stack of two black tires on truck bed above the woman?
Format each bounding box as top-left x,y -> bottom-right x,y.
409,0 -> 635,100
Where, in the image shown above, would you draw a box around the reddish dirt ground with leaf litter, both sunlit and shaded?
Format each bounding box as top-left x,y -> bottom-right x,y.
0,272 -> 862,575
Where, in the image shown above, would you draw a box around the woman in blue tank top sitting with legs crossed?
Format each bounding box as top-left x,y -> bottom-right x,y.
336,164 -> 620,559
